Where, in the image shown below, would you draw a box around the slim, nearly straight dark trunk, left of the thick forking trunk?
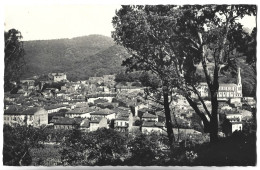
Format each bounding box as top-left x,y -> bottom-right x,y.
163,88 -> 174,146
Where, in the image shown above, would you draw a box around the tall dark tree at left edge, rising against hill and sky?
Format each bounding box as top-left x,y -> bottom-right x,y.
4,29 -> 25,91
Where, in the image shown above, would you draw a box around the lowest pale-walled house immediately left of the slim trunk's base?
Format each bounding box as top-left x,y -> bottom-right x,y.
142,121 -> 164,134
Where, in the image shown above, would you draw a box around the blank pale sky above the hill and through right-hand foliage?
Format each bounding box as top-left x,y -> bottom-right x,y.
4,4 -> 256,41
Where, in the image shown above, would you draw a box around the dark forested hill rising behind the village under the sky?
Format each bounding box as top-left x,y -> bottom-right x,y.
23,35 -> 126,81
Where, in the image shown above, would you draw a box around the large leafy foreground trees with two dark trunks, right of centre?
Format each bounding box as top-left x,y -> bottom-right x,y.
112,5 -> 256,143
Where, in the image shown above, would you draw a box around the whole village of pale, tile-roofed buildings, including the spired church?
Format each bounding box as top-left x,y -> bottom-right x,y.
4,69 -> 256,140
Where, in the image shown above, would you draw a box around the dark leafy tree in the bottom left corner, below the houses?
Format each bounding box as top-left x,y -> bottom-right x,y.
3,125 -> 47,166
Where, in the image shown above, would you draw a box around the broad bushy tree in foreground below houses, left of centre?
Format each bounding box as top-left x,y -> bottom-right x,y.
61,128 -> 126,165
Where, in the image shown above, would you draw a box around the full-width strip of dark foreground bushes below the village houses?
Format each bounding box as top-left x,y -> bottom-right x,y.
3,125 -> 256,166
